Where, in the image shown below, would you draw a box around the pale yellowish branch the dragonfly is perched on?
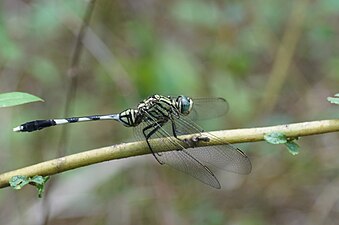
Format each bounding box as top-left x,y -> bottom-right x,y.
0,120 -> 339,188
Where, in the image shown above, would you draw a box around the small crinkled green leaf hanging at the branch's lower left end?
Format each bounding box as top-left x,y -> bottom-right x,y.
9,175 -> 49,198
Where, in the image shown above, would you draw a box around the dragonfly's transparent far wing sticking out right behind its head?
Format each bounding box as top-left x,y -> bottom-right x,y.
188,98 -> 229,121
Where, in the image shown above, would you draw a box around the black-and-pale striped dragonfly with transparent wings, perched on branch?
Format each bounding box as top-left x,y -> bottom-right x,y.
13,94 -> 252,189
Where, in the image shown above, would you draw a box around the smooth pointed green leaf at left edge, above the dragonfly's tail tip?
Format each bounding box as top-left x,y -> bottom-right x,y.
0,92 -> 43,107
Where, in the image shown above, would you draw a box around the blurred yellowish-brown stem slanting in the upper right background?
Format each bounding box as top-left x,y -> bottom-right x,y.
261,0 -> 308,112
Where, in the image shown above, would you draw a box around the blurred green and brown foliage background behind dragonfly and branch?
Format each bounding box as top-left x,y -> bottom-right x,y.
0,0 -> 339,225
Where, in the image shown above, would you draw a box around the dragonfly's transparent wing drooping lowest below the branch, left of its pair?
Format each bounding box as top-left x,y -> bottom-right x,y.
134,116 -> 220,189
